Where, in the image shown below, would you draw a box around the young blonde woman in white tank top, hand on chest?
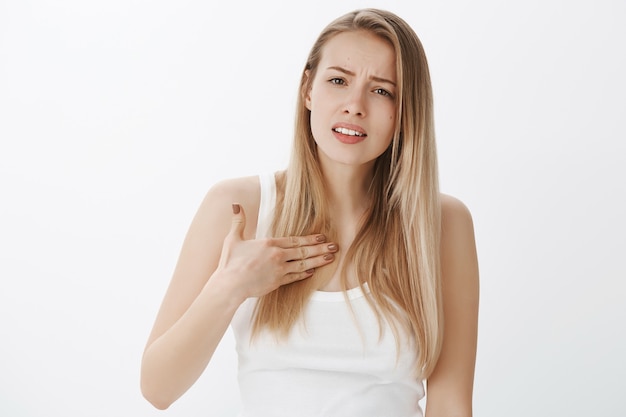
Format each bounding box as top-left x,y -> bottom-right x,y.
141,9 -> 478,417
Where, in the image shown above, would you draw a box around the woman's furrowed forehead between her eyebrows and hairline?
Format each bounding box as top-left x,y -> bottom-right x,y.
320,30 -> 396,81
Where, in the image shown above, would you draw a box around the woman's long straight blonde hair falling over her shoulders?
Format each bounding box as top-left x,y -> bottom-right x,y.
253,9 -> 443,378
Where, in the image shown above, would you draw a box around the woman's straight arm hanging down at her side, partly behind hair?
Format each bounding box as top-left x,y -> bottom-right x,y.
426,195 -> 479,417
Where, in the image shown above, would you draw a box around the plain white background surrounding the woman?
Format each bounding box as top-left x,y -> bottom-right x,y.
0,0 -> 626,417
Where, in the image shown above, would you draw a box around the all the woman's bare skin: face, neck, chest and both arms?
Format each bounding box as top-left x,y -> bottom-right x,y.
141,27 -> 478,417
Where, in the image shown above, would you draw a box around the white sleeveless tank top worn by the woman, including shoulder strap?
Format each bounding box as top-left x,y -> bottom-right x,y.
231,175 -> 424,417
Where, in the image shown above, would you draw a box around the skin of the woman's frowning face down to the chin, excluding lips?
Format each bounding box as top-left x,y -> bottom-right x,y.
305,31 -> 396,171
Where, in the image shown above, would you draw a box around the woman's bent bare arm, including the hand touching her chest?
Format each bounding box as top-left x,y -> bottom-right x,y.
141,179 -> 333,409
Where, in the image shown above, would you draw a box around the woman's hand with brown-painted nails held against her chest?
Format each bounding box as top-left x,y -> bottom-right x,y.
211,204 -> 338,299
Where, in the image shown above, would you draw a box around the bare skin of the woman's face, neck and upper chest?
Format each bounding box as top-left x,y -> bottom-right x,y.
305,31 -> 396,291
